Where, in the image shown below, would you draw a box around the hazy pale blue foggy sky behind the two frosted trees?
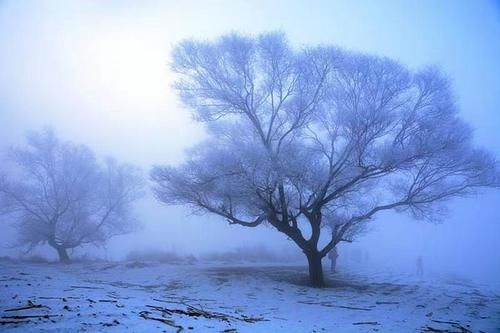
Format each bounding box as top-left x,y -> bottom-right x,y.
0,0 -> 500,283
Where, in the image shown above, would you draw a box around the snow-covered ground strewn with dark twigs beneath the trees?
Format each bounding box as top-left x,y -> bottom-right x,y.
0,262 -> 500,332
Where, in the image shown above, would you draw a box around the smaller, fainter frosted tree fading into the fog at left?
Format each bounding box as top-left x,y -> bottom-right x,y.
0,130 -> 143,262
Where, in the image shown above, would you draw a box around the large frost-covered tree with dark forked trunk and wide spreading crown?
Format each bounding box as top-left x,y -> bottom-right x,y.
151,33 -> 498,286
